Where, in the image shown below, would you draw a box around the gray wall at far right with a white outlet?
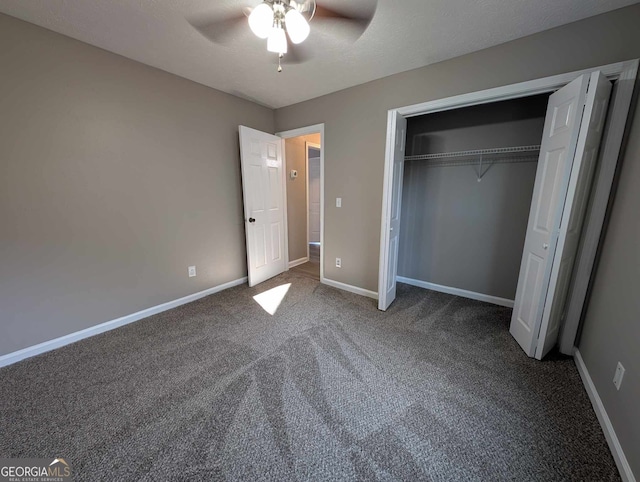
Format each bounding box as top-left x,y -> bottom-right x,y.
579,98 -> 640,474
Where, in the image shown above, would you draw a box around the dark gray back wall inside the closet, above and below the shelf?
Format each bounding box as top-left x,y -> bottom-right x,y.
398,95 -> 549,300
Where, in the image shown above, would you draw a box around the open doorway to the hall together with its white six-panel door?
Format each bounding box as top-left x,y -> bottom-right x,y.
238,124 -> 324,287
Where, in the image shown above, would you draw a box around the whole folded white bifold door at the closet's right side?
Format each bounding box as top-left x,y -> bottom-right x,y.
510,72 -> 611,360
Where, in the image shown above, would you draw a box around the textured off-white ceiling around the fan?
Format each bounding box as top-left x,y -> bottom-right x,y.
0,0 -> 637,108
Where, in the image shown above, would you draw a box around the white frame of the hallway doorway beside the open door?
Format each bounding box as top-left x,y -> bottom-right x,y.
275,123 -> 325,283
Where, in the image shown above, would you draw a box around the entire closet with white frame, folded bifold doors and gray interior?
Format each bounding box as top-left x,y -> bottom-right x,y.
378,59 -> 639,359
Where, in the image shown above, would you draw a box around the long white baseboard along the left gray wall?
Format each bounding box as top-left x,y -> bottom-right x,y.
0,277 -> 247,368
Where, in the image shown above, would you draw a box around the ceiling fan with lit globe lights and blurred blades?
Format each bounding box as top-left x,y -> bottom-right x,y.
188,0 -> 377,72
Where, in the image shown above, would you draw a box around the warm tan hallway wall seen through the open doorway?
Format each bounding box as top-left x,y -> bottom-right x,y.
285,134 -> 320,261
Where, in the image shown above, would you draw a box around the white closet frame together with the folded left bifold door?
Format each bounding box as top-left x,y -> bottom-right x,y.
378,60 -> 638,353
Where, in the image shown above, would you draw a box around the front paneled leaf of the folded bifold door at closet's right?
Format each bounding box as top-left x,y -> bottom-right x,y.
509,75 -> 588,356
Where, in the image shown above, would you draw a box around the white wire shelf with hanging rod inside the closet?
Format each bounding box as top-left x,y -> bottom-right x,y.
404,145 -> 540,166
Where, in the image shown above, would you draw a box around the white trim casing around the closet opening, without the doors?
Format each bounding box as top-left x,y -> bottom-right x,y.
378,59 -> 639,355
